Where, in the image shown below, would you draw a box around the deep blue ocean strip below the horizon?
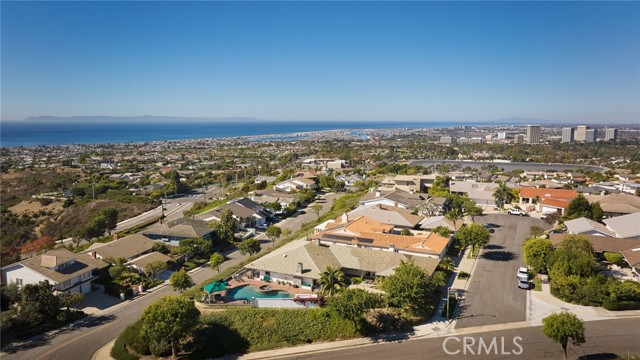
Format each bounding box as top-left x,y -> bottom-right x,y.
0,121 -> 489,147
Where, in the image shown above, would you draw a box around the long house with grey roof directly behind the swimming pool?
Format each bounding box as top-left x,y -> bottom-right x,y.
245,240 -> 439,287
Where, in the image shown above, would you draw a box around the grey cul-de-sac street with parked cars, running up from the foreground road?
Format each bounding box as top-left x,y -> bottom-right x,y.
456,214 -> 549,328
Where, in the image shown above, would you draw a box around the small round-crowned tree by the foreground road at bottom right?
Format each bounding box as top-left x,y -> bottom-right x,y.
542,311 -> 586,360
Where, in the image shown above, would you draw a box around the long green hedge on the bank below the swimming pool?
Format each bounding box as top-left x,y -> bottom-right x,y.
189,308 -> 358,359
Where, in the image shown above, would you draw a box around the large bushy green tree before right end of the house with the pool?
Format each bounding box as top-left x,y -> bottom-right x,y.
381,261 -> 433,316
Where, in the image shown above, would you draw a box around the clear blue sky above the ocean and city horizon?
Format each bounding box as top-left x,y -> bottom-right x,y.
1,1 -> 640,123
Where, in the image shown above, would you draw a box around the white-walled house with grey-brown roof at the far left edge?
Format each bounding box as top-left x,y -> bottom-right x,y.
2,249 -> 108,294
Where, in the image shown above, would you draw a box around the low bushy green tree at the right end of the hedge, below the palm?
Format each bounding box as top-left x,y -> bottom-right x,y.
328,289 -> 382,331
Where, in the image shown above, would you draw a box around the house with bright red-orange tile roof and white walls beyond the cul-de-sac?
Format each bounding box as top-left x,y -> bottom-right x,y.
520,187 -> 578,214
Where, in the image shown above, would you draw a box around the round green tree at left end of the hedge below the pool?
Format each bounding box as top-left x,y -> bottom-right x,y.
141,296 -> 200,358
